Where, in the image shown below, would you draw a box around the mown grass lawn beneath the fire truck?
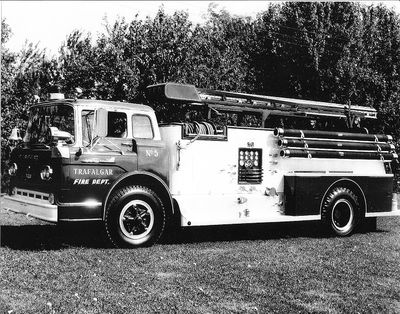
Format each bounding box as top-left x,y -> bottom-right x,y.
0,205 -> 400,313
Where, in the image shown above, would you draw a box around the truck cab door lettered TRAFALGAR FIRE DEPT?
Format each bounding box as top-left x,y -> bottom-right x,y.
59,109 -> 138,220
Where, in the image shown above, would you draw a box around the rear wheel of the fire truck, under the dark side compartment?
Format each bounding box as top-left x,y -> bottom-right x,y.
321,187 -> 361,237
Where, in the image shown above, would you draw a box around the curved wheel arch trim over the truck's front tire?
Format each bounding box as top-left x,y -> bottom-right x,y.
103,173 -> 174,218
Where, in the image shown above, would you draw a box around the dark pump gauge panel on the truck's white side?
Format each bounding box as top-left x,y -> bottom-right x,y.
238,148 -> 263,184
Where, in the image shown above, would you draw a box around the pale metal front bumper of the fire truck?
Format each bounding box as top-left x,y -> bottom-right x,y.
2,189 -> 58,222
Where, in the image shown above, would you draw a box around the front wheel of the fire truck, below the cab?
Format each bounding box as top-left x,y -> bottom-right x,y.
104,185 -> 166,248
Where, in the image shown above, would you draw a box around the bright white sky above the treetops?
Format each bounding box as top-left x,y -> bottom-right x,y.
1,0 -> 400,54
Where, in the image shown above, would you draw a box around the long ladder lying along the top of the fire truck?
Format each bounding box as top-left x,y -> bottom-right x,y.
147,83 -> 377,120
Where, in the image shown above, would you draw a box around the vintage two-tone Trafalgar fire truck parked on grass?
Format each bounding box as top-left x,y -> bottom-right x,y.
3,83 -> 400,247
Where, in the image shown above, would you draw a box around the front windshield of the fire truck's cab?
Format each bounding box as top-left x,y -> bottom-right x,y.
24,104 -> 75,144
